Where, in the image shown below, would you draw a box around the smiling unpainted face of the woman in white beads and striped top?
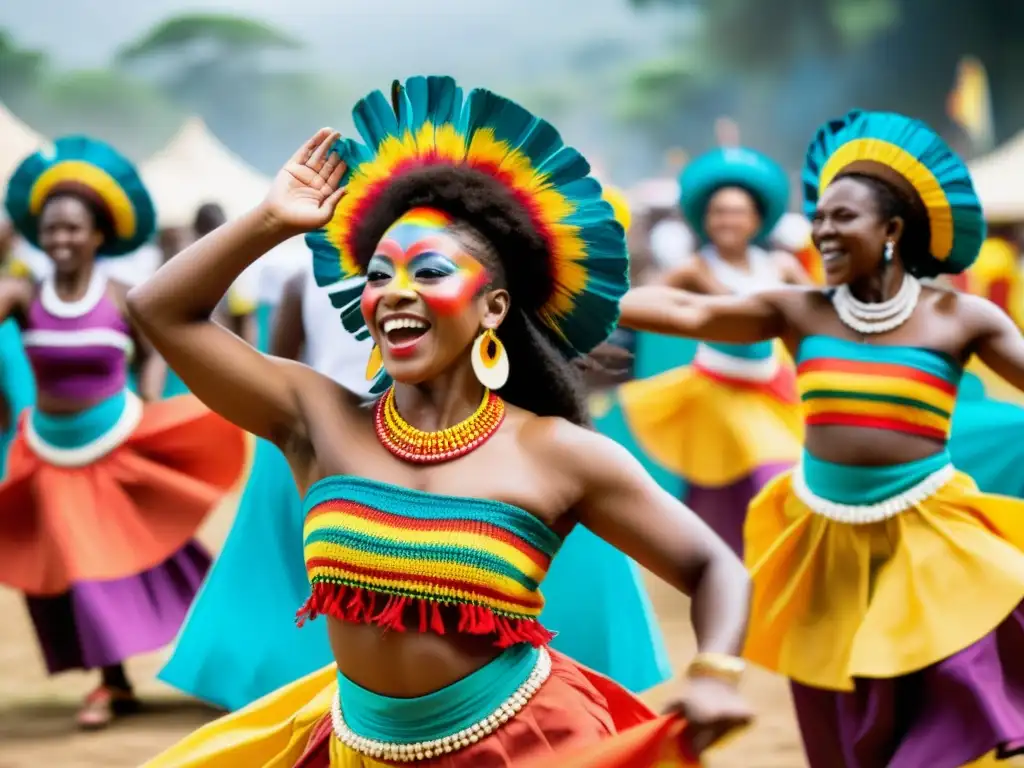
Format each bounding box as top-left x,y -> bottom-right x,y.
811,176 -> 902,286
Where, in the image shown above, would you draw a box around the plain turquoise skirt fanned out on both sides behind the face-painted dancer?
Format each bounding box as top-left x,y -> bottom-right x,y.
159,440 -> 672,710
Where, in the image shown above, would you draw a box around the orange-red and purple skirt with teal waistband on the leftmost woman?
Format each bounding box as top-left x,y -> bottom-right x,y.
0,391 -> 246,672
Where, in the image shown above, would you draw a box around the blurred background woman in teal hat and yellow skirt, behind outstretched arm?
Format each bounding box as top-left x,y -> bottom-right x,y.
618,147 -> 809,554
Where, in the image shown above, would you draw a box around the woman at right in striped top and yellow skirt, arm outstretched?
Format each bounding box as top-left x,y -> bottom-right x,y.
623,112 -> 1024,768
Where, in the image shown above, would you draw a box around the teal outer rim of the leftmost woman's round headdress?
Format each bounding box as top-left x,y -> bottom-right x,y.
5,136 -> 157,257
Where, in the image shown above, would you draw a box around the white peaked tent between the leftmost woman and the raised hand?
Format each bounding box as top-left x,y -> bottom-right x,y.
140,118 -> 270,228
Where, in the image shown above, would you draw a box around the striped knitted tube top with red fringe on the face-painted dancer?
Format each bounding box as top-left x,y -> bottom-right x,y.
297,475 -> 561,648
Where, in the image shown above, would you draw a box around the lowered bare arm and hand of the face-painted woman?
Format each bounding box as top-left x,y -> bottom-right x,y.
556,425 -> 753,753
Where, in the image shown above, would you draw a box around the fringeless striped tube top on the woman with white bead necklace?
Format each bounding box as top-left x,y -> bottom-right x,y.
797,336 -> 963,440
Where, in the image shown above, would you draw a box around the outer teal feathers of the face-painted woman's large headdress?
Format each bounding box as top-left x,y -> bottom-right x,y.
306,77 -> 629,360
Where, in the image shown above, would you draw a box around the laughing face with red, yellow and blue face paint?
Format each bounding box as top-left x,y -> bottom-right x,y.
361,208 -> 508,384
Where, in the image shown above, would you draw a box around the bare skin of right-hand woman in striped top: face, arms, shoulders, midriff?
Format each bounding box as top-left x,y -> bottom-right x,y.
621,177 -> 1024,466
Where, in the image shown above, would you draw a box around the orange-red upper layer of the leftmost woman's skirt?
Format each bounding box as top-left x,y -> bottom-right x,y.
0,395 -> 248,596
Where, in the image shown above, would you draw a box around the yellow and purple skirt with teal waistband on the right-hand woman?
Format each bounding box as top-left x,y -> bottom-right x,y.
744,453 -> 1024,768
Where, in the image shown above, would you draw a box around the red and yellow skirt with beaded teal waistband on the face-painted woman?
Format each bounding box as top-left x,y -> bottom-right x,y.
145,645 -> 696,768
